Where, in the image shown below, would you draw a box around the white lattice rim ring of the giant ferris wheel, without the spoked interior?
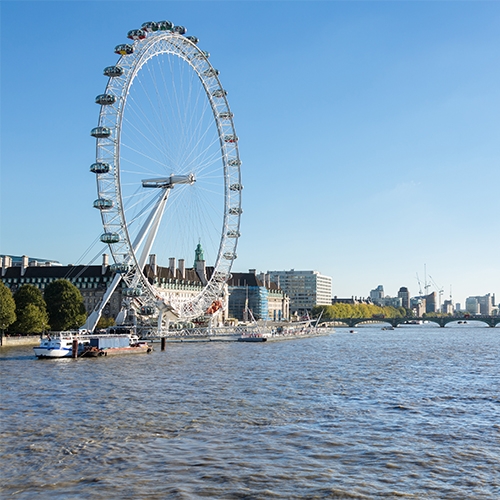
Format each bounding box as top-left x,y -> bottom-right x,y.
92,22 -> 242,319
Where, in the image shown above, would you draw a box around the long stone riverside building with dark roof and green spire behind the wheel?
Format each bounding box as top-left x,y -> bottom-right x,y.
0,254 -> 289,321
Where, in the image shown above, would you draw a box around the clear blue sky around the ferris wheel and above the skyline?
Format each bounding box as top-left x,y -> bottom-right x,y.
0,1 -> 500,304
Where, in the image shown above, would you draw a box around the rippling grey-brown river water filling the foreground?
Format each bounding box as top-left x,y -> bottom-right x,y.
0,325 -> 500,499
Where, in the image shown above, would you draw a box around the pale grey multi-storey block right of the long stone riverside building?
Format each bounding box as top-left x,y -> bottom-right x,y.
267,269 -> 332,315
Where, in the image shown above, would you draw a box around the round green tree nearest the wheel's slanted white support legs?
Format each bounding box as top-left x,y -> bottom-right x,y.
44,279 -> 87,331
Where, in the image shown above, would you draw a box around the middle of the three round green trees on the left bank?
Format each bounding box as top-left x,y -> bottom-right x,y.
10,285 -> 49,334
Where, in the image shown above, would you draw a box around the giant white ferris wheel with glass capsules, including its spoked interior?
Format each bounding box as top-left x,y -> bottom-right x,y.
90,21 -> 242,319
